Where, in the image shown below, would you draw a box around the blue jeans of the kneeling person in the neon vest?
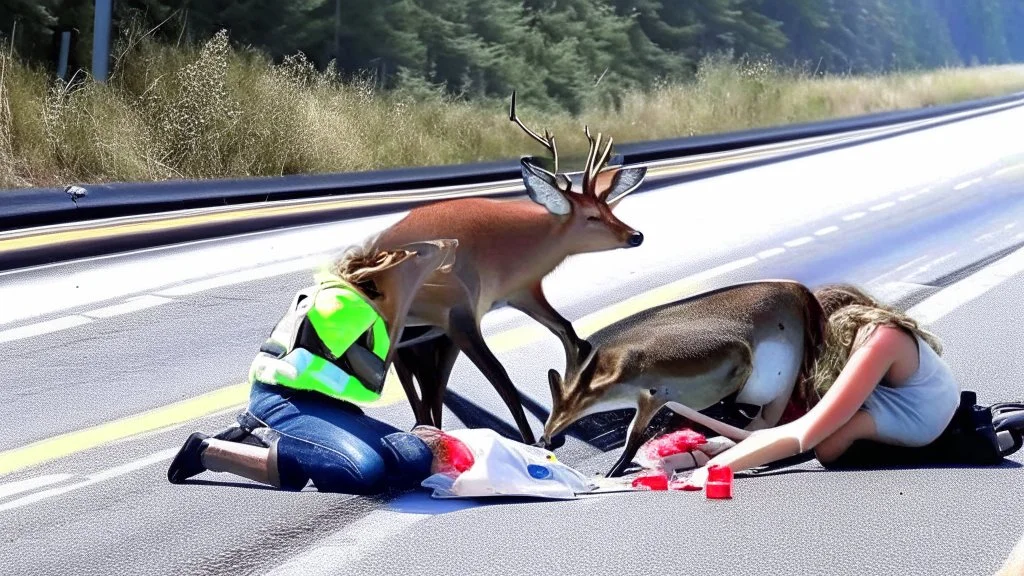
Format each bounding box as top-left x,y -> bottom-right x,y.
239,382 -> 433,495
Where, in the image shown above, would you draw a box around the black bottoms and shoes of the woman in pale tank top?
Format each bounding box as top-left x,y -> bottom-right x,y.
822,390 -> 1024,469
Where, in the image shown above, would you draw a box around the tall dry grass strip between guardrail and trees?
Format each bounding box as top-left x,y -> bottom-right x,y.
0,34 -> 1024,188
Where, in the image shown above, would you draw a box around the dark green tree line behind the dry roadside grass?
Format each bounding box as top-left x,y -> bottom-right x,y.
0,0 -> 1024,113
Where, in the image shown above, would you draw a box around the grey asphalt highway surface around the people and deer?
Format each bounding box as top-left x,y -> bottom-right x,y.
0,104 -> 1024,575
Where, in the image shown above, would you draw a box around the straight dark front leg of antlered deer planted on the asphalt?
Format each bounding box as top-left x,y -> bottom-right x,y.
449,308 -> 537,444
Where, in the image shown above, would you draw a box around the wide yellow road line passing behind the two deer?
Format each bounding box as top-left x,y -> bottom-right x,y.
0,258 -> 756,476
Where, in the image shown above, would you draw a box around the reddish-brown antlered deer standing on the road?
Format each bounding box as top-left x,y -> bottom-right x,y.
376,91 -> 647,444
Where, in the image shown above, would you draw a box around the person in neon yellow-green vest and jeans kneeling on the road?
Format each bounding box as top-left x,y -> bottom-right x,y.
167,235 -> 455,494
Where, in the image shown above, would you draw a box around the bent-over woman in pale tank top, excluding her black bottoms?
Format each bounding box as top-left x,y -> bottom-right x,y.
687,285 -> 961,489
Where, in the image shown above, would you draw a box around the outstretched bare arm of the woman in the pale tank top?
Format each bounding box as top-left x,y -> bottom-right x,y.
689,327 -> 906,487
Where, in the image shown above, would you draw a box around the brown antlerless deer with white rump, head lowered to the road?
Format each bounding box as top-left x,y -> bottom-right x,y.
542,281 -> 825,477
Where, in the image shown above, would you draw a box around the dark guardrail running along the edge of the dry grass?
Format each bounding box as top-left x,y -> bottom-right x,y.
8,87 -> 1024,231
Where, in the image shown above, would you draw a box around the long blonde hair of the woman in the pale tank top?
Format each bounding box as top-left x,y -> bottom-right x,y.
808,284 -> 942,403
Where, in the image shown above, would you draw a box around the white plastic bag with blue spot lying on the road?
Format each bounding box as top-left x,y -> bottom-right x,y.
422,428 -> 596,499
